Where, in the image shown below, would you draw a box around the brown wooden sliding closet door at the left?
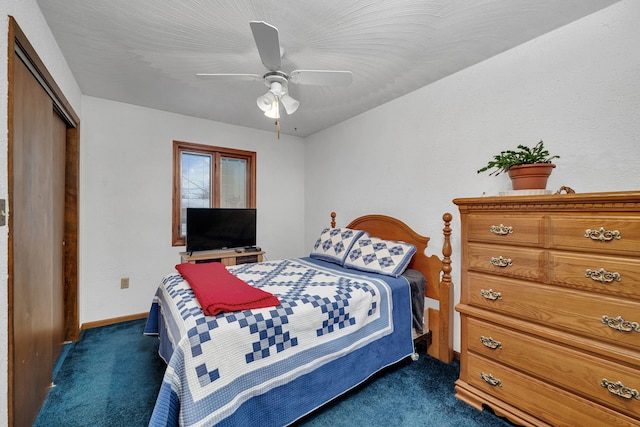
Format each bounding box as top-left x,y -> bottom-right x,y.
10,59 -> 65,426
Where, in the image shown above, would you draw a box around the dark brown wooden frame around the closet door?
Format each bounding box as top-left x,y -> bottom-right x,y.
7,16 -> 80,425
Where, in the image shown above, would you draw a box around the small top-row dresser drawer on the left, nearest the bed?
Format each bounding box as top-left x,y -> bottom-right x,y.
467,215 -> 544,246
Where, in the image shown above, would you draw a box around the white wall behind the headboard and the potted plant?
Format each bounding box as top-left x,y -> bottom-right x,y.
305,0 -> 640,349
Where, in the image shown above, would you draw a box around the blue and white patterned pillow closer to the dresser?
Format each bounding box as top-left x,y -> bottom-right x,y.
344,235 -> 416,277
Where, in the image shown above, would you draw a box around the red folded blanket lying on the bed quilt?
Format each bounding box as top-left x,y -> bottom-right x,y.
176,262 -> 280,316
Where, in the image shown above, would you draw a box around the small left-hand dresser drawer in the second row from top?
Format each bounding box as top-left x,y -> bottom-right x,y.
467,243 -> 544,280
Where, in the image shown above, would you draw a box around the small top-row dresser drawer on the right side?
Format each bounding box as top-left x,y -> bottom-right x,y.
548,216 -> 640,256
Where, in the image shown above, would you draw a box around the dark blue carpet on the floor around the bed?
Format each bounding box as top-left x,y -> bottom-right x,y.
34,320 -> 511,427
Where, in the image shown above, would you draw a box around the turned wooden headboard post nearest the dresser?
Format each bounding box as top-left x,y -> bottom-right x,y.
438,216 -> 453,363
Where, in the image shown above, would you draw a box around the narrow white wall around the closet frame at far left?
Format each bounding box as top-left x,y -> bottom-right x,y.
0,0 -> 81,425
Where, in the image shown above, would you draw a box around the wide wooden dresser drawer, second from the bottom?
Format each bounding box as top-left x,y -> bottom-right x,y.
466,318 -> 640,416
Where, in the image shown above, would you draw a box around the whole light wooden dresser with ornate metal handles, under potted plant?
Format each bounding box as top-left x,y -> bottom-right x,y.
454,191 -> 640,427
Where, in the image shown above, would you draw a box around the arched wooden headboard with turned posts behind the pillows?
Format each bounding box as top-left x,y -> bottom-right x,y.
331,212 -> 453,363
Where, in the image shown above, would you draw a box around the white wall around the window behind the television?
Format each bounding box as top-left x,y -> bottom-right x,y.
80,96 -> 308,323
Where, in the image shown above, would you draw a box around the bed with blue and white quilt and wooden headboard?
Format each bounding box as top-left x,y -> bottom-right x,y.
145,213 -> 453,426
